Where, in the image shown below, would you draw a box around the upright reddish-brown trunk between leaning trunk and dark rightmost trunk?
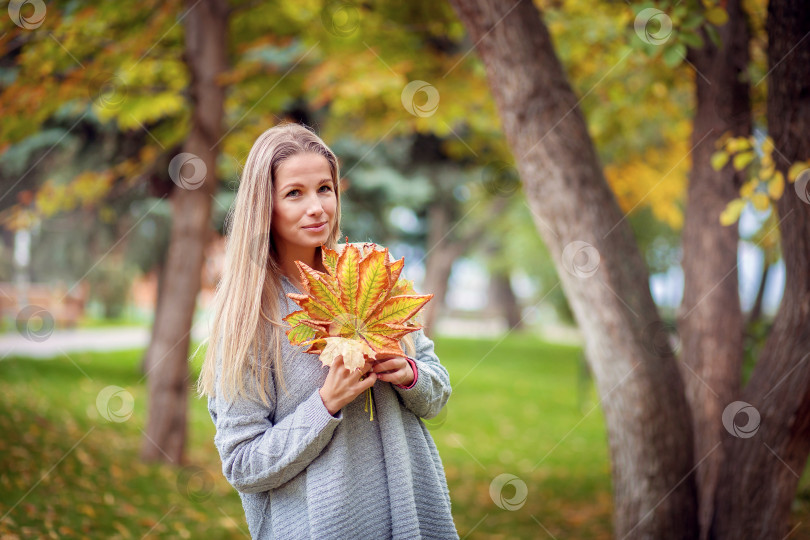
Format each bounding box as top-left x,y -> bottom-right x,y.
679,0 -> 751,538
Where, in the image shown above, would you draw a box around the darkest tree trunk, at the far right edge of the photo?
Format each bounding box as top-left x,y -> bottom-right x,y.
713,0 -> 810,539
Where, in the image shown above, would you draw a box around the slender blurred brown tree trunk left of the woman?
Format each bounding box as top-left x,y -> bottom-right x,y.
141,0 -> 228,464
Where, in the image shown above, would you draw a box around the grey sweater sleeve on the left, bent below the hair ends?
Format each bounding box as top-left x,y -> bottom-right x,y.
208,356 -> 343,493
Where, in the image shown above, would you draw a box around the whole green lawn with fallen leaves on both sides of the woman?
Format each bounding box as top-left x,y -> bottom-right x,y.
0,335 -> 612,538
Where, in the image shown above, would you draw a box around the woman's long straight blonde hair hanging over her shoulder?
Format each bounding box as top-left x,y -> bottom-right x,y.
195,123 -> 414,404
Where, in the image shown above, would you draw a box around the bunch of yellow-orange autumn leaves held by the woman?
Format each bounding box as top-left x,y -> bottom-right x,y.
284,242 -> 433,369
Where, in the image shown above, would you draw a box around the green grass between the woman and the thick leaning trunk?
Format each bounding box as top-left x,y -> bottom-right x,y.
431,335 -> 612,538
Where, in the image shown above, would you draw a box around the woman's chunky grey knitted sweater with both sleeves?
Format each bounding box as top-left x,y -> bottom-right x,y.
208,277 -> 458,540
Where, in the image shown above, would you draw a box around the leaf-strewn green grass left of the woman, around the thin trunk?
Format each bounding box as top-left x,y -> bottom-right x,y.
0,351 -> 247,539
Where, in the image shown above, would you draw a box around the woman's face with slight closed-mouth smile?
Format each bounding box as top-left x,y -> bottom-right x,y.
271,153 -> 337,253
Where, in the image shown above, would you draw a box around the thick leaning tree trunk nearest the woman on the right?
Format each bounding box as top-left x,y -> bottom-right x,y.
451,0 -> 698,539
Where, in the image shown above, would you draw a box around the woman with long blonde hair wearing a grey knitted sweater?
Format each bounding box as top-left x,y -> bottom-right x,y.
198,124 -> 458,539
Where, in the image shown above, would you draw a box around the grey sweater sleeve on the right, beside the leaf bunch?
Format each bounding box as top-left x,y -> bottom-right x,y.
394,329 -> 452,418
